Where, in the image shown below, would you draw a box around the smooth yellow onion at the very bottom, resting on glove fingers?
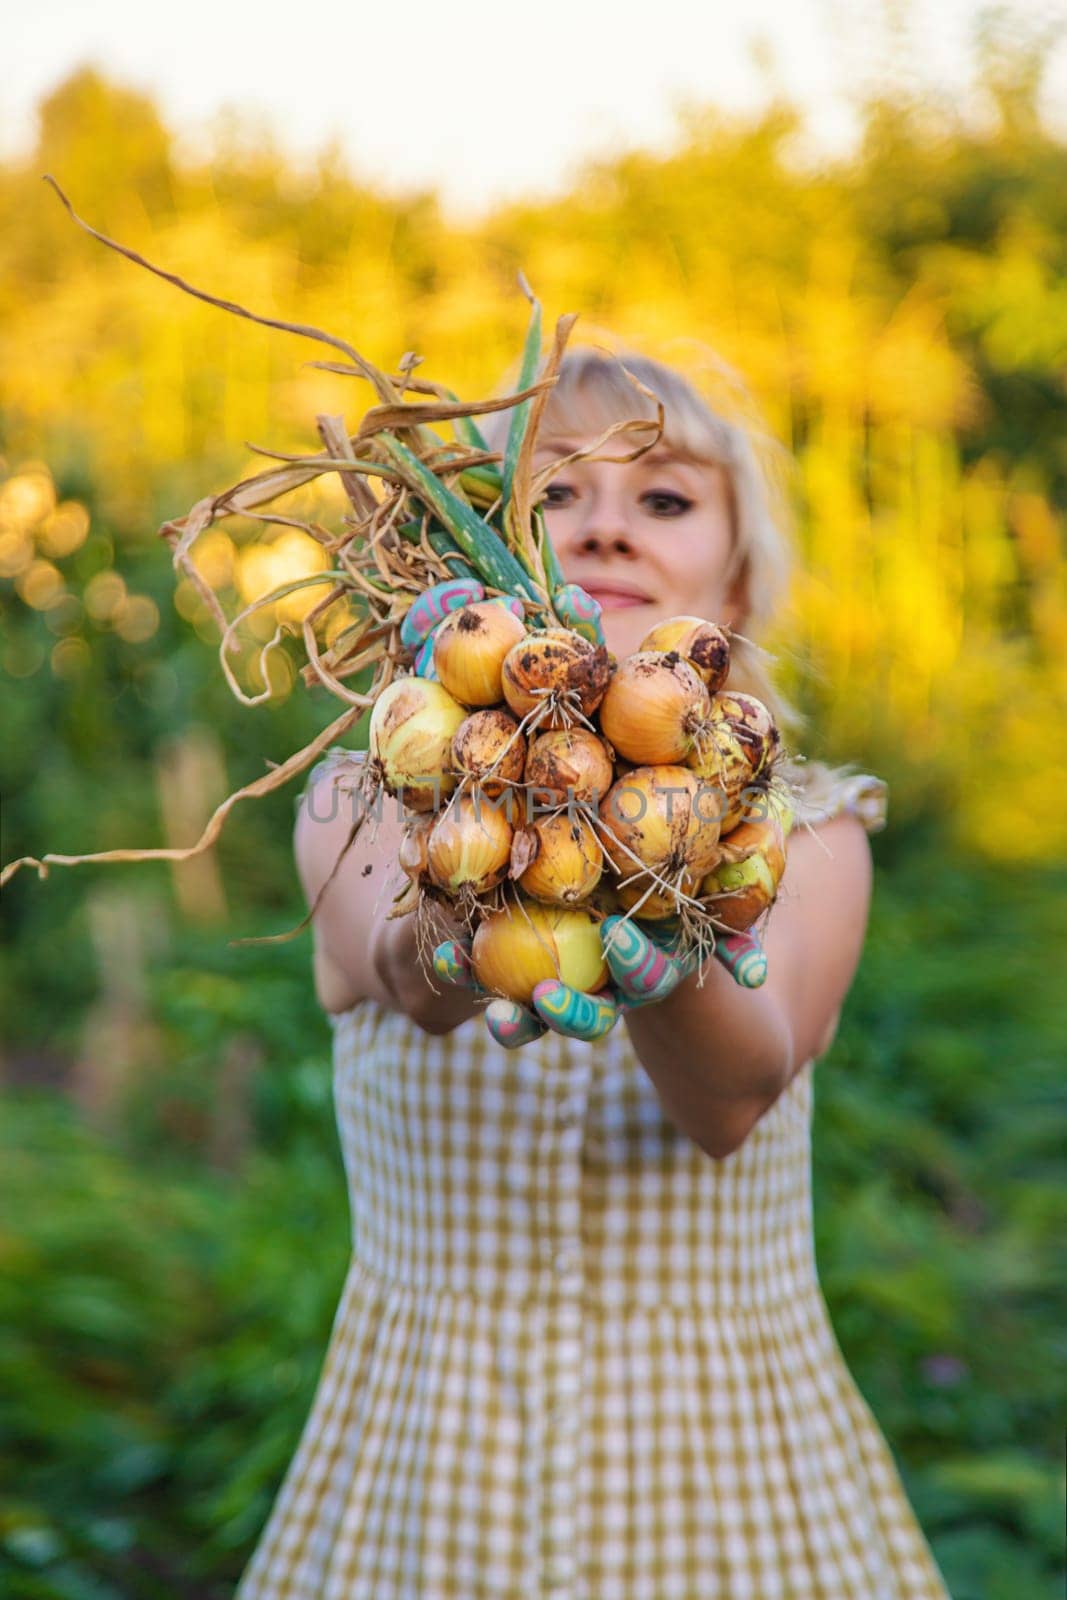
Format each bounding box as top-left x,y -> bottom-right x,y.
470,901 -> 608,1005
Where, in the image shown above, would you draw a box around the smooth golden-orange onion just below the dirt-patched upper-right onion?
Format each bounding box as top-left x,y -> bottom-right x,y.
600,650 -> 710,766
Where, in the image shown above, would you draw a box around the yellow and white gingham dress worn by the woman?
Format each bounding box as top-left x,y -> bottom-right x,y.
238,780 -> 947,1600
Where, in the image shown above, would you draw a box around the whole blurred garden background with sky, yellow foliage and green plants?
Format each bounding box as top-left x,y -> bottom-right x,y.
0,0 -> 1067,1600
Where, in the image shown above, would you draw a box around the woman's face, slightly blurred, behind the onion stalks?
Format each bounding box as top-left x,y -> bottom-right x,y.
536,434 -> 741,659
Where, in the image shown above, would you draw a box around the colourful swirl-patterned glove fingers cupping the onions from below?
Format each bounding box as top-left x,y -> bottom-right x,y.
434,917 -> 766,1050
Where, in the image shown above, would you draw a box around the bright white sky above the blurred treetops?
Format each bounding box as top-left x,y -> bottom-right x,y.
0,0 -> 1067,214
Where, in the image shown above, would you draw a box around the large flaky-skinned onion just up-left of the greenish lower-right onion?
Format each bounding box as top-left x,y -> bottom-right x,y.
600,766 -> 720,891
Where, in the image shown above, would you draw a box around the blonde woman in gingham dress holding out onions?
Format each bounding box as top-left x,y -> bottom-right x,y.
238,352 -> 945,1600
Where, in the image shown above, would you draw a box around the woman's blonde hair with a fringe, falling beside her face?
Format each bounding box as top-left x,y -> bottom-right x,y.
485,346 -> 853,821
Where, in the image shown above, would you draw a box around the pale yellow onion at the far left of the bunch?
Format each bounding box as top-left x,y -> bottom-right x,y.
370,678 -> 467,811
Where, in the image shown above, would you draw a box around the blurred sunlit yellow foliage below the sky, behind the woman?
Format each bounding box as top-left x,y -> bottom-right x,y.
0,74 -> 1067,859
